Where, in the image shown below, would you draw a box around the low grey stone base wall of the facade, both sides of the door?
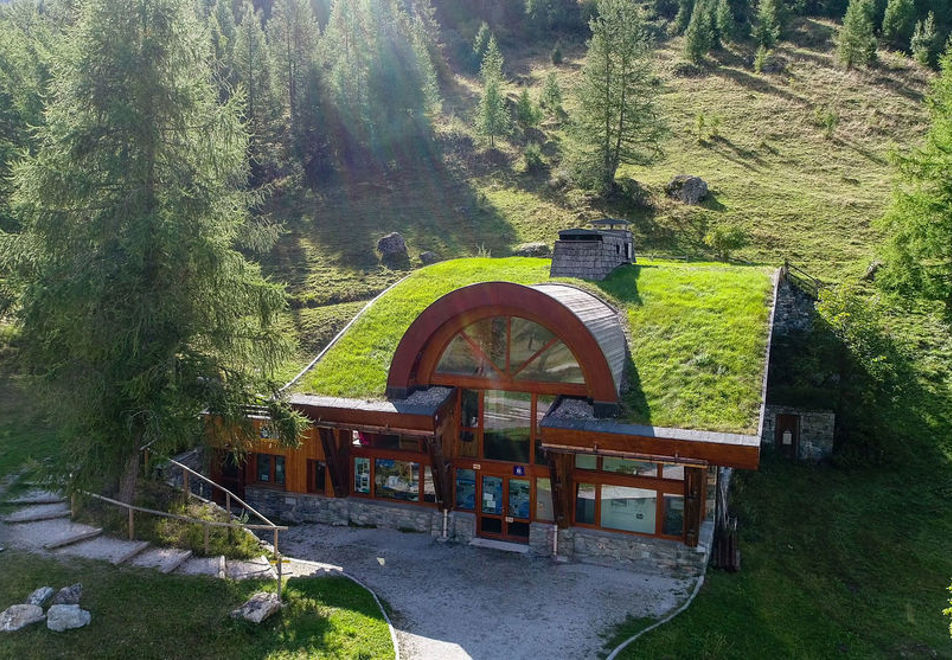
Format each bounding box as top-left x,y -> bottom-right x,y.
245,487 -> 714,576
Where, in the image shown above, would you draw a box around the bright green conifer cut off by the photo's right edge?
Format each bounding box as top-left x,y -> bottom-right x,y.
876,44 -> 952,320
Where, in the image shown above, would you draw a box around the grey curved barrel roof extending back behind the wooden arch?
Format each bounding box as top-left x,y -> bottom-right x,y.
530,283 -> 628,390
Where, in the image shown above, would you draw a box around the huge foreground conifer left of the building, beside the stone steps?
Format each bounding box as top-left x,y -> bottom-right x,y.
8,0 -> 301,502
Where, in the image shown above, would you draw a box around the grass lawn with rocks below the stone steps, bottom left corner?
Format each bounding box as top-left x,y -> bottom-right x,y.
0,550 -> 393,659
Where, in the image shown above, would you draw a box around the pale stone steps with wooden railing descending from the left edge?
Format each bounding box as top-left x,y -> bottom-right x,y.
0,490 -> 277,580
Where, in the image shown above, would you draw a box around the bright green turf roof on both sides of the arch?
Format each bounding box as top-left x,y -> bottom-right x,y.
294,257 -> 772,433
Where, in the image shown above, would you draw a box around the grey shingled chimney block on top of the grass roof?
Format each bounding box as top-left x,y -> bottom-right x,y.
549,218 -> 635,280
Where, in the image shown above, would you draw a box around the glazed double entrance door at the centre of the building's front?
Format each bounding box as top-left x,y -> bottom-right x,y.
476,474 -> 531,543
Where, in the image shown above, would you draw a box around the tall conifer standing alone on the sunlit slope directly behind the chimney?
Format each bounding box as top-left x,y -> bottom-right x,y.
572,0 -> 666,190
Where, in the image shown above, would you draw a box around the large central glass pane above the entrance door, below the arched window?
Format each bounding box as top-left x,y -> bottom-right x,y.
483,390 -> 532,463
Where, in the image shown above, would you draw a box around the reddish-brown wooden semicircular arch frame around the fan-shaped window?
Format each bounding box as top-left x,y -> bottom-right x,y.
387,282 -> 618,409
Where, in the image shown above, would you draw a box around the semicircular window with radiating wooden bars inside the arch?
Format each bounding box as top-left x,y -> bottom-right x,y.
435,316 -> 585,384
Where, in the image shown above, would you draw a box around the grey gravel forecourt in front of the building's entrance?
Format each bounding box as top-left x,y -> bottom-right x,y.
281,524 -> 694,660
